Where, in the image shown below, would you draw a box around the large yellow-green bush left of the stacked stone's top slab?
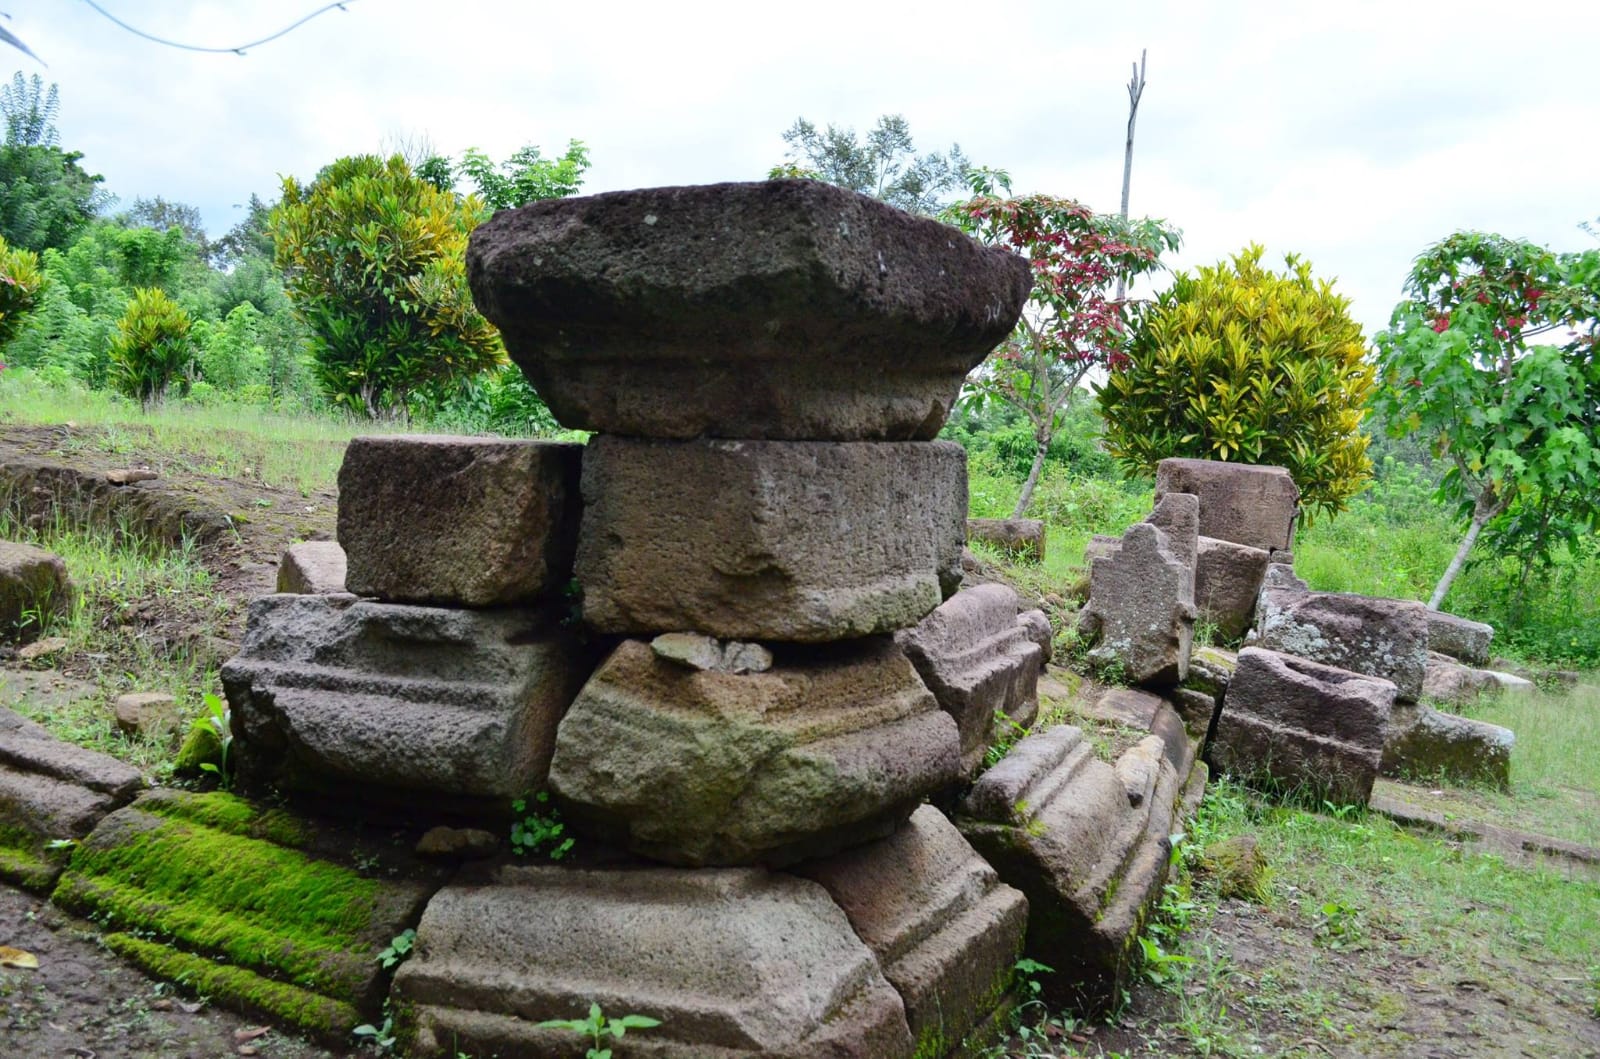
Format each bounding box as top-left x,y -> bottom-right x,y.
272,155 -> 504,418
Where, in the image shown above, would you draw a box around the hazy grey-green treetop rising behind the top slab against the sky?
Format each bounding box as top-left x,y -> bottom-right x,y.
768,114 -> 973,216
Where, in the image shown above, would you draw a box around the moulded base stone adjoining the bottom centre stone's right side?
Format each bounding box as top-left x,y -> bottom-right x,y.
794,805 -> 1027,1056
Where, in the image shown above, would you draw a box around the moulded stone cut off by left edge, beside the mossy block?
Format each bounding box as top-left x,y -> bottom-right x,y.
0,709 -> 144,893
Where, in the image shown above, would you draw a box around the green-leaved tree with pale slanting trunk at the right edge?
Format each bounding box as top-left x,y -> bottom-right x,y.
1374,232 -> 1600,608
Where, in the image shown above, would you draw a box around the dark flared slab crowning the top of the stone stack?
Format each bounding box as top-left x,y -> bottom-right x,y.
467,181 -> 1032,440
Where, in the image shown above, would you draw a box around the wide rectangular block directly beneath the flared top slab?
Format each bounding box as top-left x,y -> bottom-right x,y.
578,437 -> 966,641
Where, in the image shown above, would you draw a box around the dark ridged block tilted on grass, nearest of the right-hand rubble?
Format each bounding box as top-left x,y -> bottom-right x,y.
1210,648 -> 1395,805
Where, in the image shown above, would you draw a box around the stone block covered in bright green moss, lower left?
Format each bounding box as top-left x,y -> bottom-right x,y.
53,790 -> 443,1043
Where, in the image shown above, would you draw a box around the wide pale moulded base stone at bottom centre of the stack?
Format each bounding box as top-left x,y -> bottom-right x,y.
394,867 -> 914,1059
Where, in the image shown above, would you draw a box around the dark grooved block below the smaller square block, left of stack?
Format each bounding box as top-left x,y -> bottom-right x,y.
222,595 -> 587,808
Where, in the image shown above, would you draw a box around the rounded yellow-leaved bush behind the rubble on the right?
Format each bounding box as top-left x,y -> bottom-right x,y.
1099,246 -> 1374,512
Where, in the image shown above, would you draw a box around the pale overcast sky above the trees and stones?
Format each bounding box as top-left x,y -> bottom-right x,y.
0,0 -> 1600,330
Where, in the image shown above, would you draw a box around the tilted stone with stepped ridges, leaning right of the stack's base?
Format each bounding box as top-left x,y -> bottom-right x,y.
957,726 -> 1179,1011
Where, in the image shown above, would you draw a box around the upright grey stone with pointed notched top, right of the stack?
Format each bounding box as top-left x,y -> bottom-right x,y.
1083,522 -> 1195,686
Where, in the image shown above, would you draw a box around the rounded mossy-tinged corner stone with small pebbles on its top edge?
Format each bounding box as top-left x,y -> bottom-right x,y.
550,638 -> 960,865
